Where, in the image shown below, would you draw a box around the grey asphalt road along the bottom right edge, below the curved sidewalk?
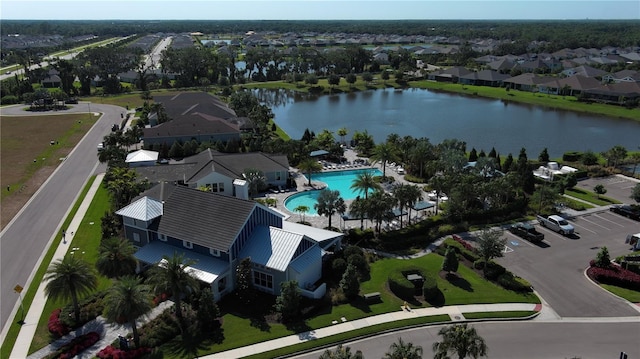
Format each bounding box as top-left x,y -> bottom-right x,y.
295,321 -> 640,359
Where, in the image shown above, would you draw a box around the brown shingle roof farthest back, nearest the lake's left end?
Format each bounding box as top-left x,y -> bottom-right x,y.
153,92 -> 236,120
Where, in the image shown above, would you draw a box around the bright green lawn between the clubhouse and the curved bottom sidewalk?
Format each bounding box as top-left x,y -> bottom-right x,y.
161,253 -> 540,357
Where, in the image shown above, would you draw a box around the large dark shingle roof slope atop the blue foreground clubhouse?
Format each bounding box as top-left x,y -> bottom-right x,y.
158,186 -> 257,252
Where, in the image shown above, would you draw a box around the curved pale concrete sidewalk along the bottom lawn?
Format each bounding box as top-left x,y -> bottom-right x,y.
201,303 -> 542,359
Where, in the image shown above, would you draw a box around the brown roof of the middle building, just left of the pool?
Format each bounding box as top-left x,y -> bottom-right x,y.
184,148 -> 289,183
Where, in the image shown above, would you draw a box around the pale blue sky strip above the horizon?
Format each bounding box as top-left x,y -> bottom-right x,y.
0,0 -> 640,20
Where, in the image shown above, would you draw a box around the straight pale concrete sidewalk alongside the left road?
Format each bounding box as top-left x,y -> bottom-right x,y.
10,174 -> 104,358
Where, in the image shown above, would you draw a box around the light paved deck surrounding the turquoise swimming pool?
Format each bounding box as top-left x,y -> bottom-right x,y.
262,149 -> 436,230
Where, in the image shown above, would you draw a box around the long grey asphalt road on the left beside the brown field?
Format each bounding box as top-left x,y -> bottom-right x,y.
0,103 -> 125,338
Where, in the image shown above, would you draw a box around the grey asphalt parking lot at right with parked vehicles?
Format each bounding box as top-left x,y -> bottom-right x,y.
497,208 -> 640,317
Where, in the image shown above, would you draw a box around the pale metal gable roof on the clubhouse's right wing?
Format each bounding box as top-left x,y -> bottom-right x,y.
240,226 -> 310,272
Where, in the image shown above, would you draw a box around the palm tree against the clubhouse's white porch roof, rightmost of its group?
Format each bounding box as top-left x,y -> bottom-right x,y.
149,252 -> 199,333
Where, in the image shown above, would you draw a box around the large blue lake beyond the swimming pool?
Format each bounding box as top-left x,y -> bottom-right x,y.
255,89 -> 640,158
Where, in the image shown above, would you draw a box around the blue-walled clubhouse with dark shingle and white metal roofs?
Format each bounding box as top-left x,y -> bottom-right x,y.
116,184 -> 342,300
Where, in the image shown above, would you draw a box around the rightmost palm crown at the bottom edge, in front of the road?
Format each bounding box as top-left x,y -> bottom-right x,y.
433,323 -> 488,359
